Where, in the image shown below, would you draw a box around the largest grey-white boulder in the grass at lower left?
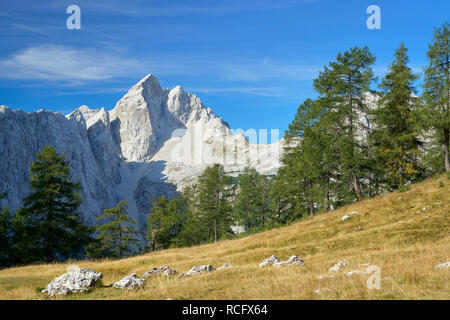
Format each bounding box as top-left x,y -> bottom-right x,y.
42,268 -> 103,296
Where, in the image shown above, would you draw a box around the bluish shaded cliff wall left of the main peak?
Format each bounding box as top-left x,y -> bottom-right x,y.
0,106 -> 118,223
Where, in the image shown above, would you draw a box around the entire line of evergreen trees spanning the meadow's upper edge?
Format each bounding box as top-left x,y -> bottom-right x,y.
0,22 -> 450,267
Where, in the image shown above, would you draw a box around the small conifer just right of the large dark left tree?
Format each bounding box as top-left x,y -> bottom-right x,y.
87,201 -> 140,258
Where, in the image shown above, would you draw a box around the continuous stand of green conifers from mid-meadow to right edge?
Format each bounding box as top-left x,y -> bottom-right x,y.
138,22 -> 450,250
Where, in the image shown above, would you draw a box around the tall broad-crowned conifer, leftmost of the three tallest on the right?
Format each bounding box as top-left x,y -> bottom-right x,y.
314,47 -> 376,200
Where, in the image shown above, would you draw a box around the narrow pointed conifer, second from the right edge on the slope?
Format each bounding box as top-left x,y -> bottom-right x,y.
374,43 -> 420,188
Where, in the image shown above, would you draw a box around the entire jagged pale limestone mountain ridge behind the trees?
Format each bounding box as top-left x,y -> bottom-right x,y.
0,75 -> 282,228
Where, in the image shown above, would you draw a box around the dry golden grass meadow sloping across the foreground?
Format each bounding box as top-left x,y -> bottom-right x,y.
0,177 -> 450,299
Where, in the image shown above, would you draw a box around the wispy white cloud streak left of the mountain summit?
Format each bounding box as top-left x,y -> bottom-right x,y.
0,45 -> 139,82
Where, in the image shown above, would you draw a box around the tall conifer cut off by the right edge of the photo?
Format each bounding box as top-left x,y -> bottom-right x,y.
422,22 -> 450,172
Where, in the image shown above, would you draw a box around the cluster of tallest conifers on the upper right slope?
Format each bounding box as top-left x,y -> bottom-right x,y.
272,22 -> 450,217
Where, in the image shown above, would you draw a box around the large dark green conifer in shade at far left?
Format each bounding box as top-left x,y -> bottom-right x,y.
14,146 -> 91,262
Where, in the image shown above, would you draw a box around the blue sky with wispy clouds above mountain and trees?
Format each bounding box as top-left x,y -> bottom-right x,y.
0,0 -> 450,139
